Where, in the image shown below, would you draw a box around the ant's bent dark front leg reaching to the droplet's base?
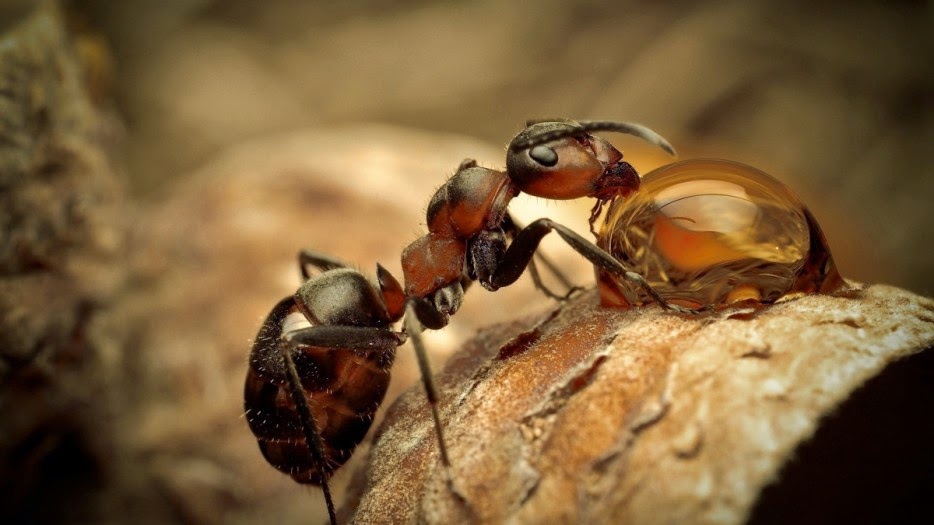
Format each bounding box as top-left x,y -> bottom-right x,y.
493,219 -> 699,313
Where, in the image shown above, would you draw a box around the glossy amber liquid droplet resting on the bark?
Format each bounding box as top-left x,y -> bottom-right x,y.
597,159 -> 843,307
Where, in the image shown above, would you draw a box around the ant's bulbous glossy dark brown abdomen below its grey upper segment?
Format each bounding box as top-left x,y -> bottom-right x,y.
244,290 -> 395,485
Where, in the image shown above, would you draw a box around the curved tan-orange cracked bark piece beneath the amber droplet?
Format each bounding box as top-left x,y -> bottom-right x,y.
344,286 -> 934,523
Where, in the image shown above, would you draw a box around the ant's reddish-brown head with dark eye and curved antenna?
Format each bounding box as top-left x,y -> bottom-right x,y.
506,120 -> 674,200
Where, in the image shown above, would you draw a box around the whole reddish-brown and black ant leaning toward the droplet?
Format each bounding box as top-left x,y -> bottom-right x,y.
244,120 -> 697,524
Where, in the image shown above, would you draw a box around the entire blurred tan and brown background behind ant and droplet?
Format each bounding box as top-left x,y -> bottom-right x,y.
0,0 -> 934,523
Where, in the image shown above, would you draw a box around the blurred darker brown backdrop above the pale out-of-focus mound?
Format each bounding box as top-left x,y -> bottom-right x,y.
84,0 -> 934,295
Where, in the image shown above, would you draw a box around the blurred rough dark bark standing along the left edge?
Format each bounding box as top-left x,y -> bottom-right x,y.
0,5 -> 124,521
